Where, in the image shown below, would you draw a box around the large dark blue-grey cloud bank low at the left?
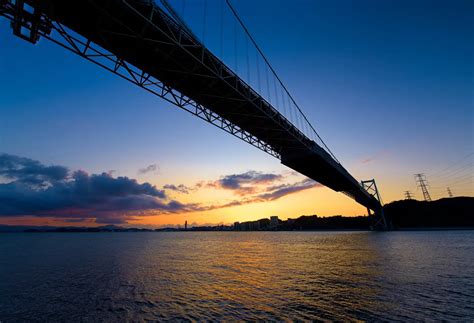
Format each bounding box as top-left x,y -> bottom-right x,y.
0,154 -> 195,223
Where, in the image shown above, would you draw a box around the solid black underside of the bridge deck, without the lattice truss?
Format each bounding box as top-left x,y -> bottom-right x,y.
19,0 -> 378,208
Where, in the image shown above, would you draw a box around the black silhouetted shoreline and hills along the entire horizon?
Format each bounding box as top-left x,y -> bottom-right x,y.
0,197 -> 474,232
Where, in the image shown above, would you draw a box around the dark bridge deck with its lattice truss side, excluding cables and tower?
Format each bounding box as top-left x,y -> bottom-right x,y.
0,0 -> 379,215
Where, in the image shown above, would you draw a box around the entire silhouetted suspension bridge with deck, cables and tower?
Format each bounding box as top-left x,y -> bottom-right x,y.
0,0 -> 389,230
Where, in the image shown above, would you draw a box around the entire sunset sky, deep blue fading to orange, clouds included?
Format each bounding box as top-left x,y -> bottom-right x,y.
0,0 -> 474,226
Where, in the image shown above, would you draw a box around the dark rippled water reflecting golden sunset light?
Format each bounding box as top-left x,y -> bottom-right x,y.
0,231 -> 474,322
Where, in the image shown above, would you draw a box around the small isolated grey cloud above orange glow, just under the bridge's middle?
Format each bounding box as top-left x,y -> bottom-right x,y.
208,170 -> 283,195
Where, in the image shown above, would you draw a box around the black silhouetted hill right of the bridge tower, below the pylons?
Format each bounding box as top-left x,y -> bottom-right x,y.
384,197 -> 474,229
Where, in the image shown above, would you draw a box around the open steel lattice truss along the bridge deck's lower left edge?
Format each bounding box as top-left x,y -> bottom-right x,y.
0,0 -> 281,159
